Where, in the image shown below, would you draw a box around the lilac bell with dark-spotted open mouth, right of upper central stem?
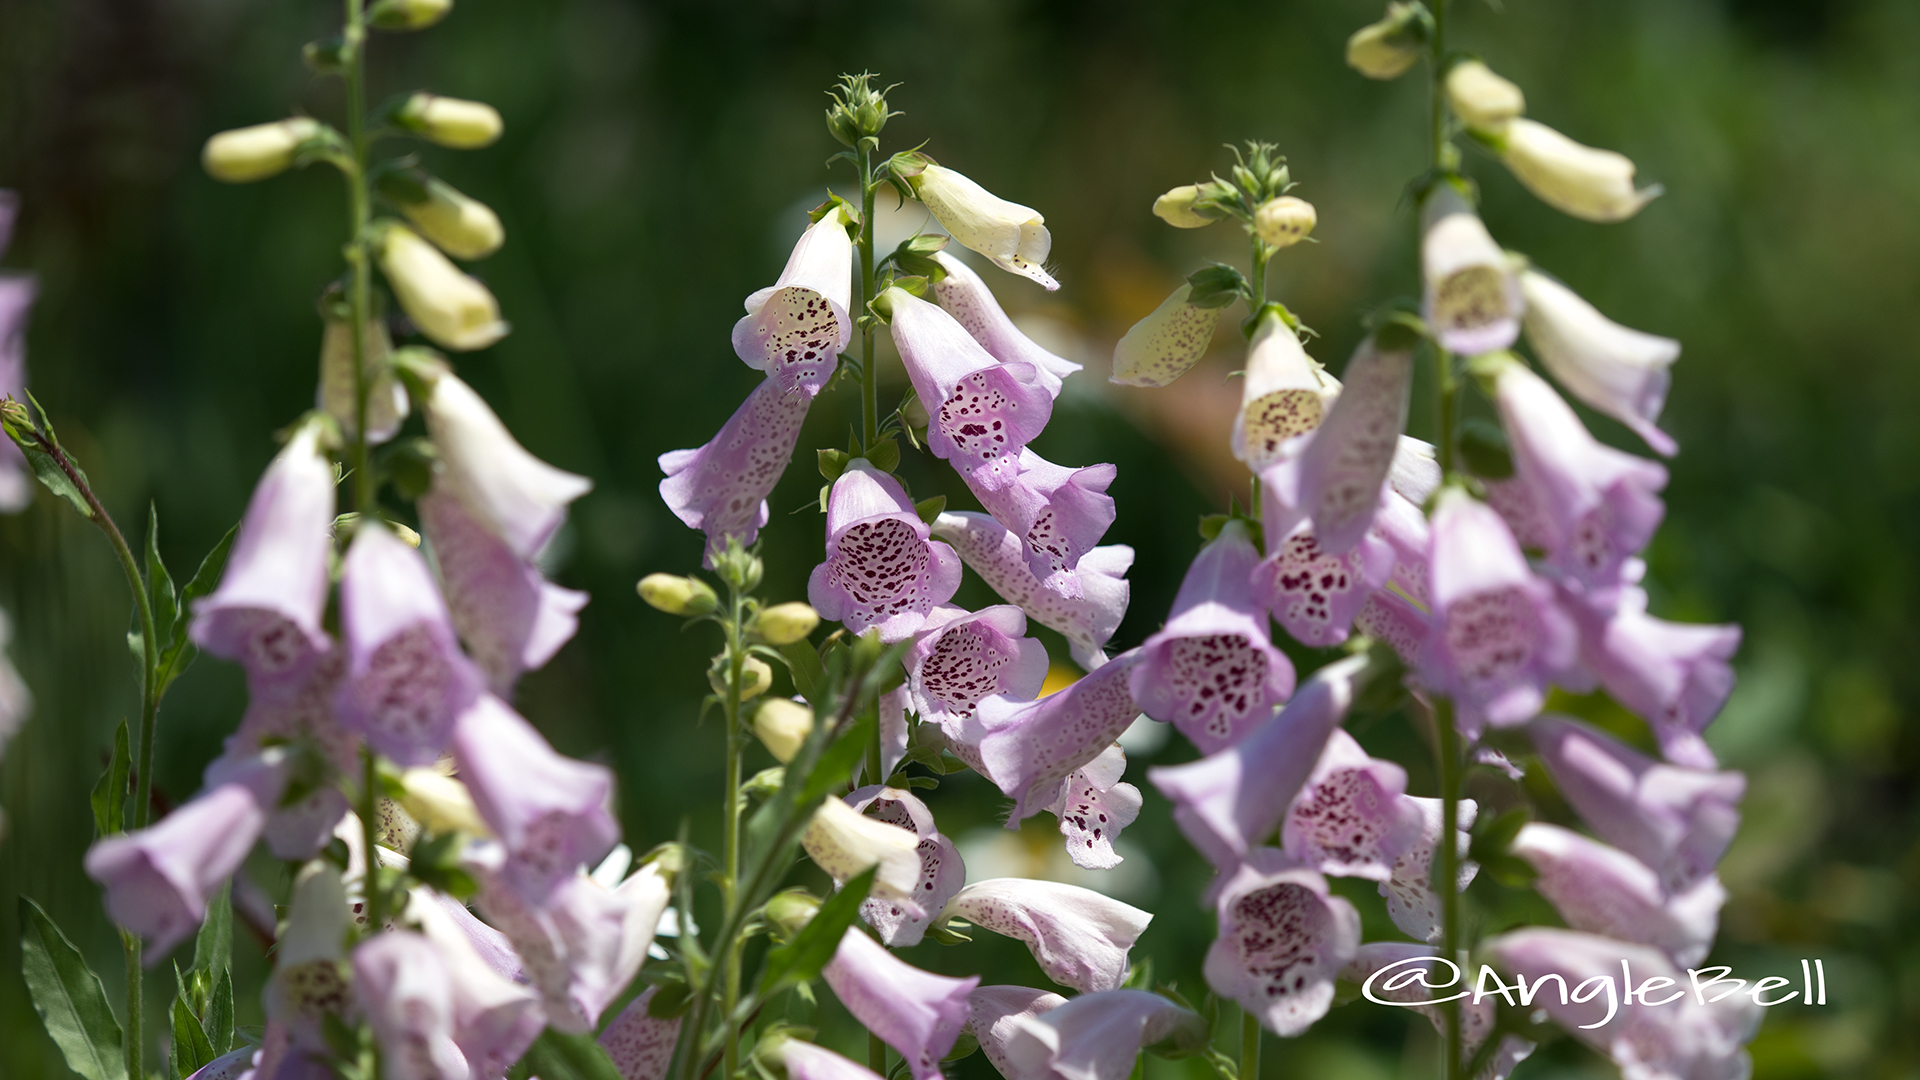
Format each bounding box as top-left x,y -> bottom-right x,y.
877,288 -> 1054,490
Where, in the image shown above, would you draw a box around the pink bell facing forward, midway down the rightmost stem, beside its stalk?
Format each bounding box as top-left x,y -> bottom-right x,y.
1419,488 -> 1574,738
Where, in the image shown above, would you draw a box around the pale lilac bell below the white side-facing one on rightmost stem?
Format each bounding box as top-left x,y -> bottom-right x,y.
1494,356 -> 1667,588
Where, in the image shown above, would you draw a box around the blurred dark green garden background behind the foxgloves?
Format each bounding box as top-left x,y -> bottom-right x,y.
0,0 -> 1920,1080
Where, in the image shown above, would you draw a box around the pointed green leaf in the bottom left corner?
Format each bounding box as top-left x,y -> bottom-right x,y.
19,896 -> 127,1080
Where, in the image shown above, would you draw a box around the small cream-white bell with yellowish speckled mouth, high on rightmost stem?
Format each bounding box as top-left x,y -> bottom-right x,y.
1421,184 -> 1524,356
